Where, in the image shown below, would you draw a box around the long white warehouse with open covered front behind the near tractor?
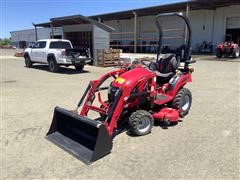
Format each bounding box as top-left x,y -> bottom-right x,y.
90,0 -> 240,52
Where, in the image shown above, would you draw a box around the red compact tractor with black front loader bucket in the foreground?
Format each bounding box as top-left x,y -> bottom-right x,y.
46,13 -> 194,164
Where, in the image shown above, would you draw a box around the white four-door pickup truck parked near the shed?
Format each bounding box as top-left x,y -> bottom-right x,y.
24,39 -> 92,72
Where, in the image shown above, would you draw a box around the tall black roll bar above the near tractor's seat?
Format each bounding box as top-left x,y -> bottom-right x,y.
156,13 -> 192,62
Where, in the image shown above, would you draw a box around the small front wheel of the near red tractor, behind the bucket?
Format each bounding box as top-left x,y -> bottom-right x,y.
128,110 -> 154,136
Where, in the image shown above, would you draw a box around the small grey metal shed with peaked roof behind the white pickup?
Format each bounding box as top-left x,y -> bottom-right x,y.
34,15 -> 114,65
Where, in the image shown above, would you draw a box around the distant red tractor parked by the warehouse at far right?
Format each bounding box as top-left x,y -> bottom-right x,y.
216,34 -> 240,58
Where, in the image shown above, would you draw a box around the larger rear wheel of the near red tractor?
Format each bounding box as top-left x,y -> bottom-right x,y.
172,88 -> 192,118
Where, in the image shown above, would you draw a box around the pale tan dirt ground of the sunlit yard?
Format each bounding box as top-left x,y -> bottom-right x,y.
0,50 -> 240,179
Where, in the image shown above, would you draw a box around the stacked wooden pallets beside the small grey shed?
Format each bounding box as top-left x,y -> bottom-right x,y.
97,48 -> 122,67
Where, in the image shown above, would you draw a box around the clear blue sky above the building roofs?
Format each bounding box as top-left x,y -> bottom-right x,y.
0,0 -> 182,38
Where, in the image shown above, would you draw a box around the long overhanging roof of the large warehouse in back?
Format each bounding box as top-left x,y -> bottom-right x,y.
89,0 -> 240,21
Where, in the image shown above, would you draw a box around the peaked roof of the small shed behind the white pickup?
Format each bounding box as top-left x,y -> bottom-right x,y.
33,14 -> 115,32
